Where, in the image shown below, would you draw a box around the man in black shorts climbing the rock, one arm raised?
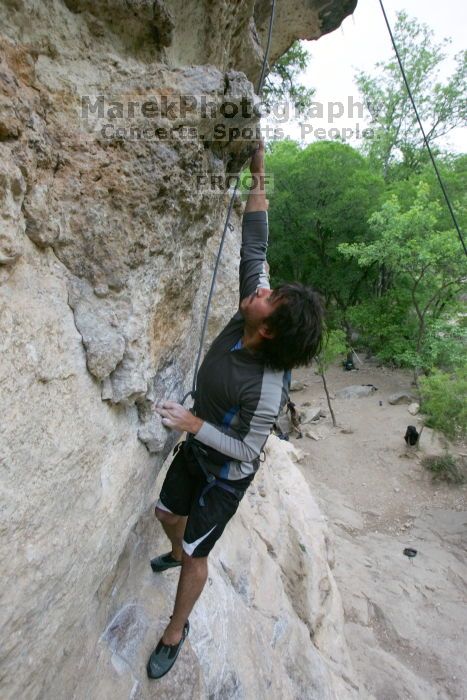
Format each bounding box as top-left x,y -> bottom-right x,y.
147,143 -> 323,678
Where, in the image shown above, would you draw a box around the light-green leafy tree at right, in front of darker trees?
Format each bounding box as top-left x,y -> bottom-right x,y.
339,182 -> 465,377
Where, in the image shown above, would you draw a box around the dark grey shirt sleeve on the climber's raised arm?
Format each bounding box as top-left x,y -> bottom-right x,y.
240,211 -> 269,300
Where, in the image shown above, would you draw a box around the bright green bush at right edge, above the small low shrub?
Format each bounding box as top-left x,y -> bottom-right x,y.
420,367 -> 467,438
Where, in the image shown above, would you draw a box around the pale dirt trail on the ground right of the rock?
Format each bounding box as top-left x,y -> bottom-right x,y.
292,362 -> 467,700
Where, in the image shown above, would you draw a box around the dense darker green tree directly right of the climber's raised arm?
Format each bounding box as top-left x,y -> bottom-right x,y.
267,141 -> 383,334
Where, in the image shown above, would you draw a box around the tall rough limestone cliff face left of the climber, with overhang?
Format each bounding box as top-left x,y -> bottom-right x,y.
0,0 -> 355,700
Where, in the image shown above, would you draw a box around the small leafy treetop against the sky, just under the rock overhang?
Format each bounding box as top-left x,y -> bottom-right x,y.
262,41 -> 315,117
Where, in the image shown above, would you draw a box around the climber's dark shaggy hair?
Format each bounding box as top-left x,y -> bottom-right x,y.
261,282 -> 324,370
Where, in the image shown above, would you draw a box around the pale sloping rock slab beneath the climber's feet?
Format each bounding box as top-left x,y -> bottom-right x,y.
60,438 -> 361,700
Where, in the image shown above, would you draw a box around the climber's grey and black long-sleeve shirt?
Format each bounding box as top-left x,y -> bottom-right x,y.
194,211 -> 290,480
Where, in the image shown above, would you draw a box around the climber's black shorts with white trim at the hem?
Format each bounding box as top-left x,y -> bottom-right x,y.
157,443 -> 254,557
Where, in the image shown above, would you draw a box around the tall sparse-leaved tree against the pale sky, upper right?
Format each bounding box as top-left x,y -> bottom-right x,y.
356,11 -> 467,179
